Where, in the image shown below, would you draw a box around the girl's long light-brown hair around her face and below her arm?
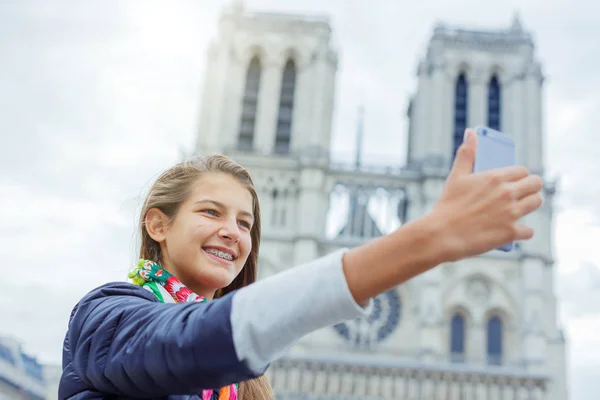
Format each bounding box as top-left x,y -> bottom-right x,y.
139,155 -> 273,400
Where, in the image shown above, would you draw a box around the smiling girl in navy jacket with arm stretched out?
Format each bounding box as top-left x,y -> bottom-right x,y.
59,131 -> 542,400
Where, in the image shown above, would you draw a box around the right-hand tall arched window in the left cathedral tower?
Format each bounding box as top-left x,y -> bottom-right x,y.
275,60 -> 296,154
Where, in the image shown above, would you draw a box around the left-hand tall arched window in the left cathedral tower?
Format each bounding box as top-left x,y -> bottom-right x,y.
238,56 -> 261,150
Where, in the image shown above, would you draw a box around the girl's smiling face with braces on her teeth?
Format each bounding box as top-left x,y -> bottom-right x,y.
149,173 -> 254,300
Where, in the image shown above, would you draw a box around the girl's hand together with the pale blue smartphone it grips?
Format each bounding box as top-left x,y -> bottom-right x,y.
423,128 -> 544,262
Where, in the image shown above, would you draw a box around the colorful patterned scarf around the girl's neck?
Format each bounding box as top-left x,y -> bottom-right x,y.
128,260 -> 238,400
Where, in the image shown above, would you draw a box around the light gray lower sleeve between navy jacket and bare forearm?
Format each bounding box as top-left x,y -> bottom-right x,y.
231,249 -> 371,372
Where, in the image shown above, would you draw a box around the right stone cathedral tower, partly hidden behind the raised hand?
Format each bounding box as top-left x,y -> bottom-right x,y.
408,16 -> 566,399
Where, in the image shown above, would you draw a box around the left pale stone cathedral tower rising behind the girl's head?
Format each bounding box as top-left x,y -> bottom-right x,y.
197,2 -> 337,275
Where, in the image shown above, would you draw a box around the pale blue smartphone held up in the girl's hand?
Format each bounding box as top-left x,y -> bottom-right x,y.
473,126 -> 516,252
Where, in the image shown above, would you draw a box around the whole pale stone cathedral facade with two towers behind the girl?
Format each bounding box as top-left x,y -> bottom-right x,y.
196,3 -> 568,400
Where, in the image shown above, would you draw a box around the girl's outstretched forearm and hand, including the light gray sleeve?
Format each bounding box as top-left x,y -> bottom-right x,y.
232,131 -> 542,376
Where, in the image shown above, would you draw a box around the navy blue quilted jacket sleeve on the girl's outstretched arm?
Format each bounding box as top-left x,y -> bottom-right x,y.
63,283 -> 255,398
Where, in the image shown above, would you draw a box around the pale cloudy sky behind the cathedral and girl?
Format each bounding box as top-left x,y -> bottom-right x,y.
0,0 -> 600,400
